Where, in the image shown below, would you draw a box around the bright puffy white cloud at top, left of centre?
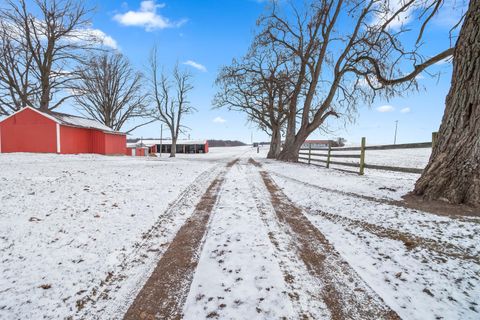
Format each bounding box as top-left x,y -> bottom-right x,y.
113,0 -> 187,31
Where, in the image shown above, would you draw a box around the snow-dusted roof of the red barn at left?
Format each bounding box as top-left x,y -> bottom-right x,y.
2,106 -> 124,134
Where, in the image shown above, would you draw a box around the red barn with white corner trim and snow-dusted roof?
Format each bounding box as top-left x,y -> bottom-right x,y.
0,107 -> 127,155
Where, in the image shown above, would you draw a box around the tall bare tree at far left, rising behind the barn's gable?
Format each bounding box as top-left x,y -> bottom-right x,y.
0,0 -> 101,113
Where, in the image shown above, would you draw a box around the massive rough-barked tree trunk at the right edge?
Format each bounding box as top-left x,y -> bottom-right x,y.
414,0 -> 480,207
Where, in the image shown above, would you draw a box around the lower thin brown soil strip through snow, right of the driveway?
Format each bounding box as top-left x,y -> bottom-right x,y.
312,210 -> 480,262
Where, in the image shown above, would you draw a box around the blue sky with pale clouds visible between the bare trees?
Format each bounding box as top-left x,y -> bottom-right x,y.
57,0 -> 464,143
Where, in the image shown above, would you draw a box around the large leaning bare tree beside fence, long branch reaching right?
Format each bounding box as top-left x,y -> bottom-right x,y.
259,0 -> 453,161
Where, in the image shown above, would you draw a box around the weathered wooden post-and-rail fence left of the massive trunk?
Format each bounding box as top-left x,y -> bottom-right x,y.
299,132 -> 437,175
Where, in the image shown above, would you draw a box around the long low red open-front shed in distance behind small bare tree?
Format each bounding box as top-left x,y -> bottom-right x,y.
137,139 -> 208,153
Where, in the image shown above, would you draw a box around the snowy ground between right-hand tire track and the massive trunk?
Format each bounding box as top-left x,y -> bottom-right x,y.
256,149 -> 480,319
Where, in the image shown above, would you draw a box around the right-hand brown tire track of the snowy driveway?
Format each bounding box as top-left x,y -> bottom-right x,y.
258,168 -> 400,319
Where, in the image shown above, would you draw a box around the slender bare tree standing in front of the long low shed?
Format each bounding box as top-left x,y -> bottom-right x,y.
150,47 -> 196,157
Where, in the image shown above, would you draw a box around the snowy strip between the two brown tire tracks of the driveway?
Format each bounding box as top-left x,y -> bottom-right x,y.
184,166 -> 292,320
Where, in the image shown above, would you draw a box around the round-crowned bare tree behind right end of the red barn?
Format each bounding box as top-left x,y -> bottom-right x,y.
72,53 -> 154,132
